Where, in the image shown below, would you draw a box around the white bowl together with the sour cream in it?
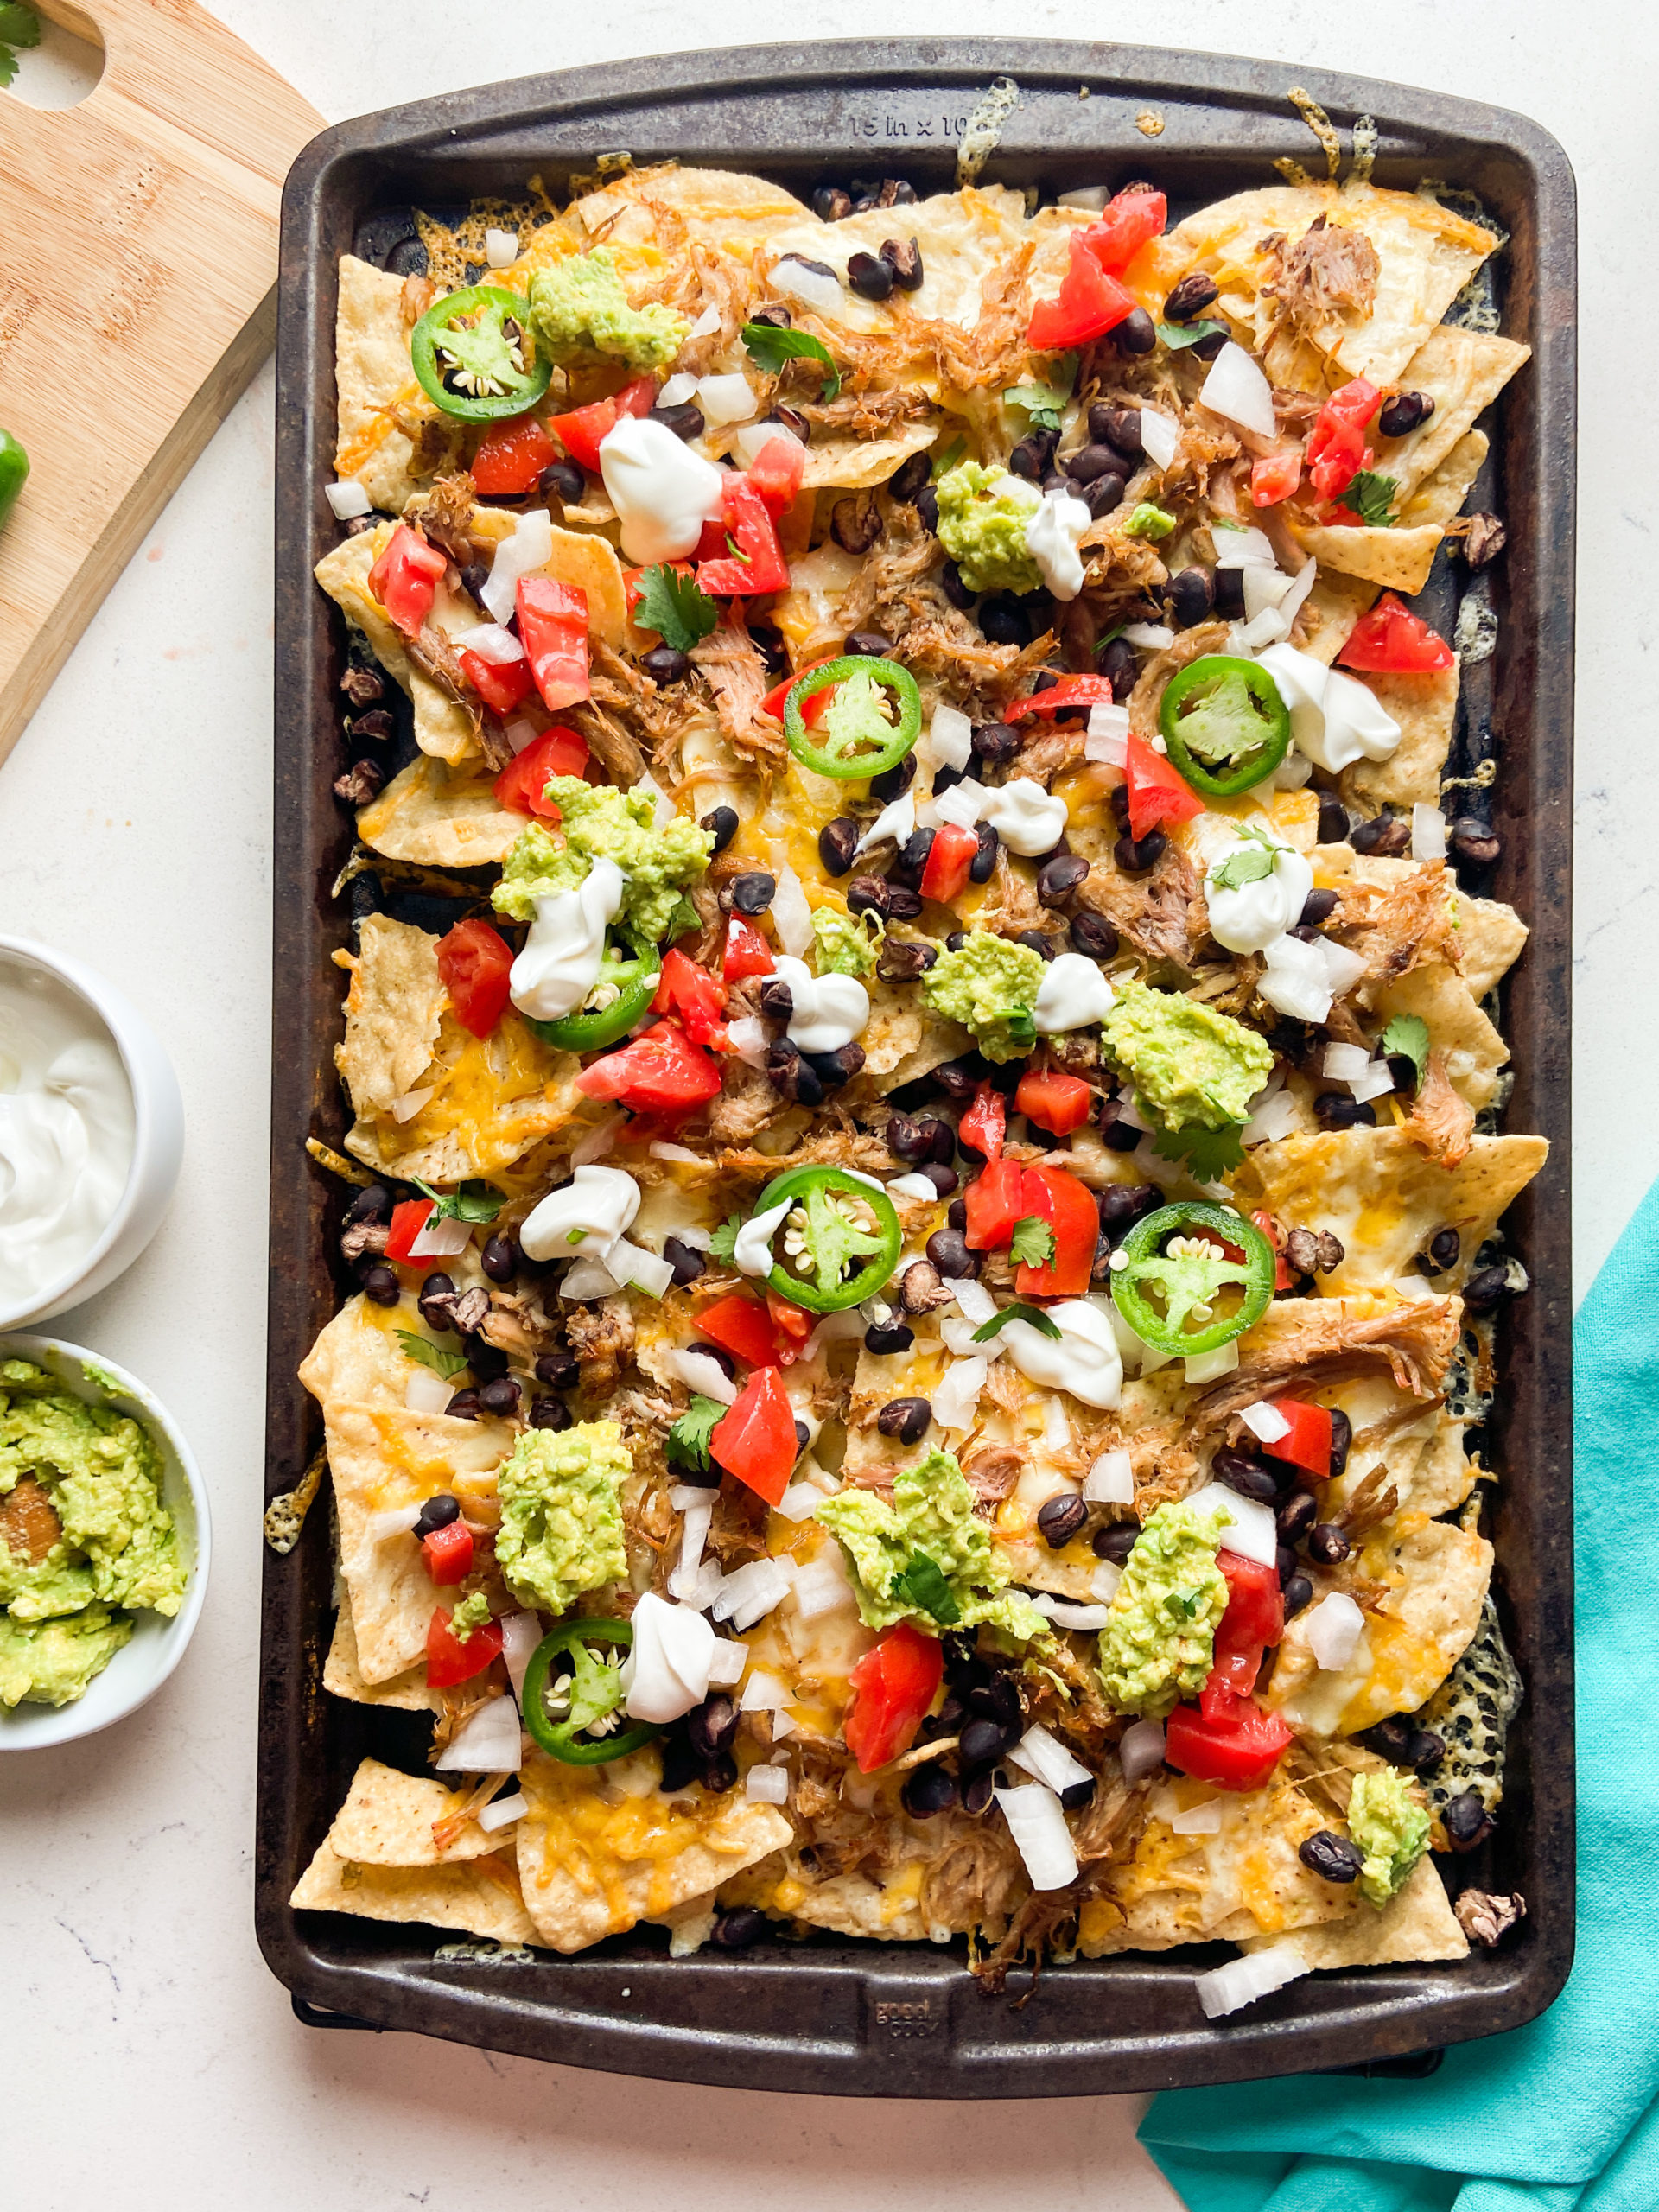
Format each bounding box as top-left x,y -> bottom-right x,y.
0,938 -> 183,1330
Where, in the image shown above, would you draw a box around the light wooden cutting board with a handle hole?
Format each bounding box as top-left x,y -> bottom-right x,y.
0,0 -> 323,761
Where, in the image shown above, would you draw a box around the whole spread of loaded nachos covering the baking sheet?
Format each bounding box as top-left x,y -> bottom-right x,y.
294,133 -> 1544,2013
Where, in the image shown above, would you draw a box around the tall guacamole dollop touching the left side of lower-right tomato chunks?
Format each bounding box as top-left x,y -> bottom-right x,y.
1099,1504 -> 1228,1721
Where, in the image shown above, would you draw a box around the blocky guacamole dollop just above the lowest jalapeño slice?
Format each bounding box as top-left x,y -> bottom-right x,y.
493,1421 -> 632,1612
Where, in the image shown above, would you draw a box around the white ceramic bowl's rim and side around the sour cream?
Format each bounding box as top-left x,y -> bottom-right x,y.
0,936 -> 183,1330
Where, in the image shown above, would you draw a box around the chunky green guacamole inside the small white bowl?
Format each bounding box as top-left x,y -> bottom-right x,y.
0,1360 -> 186,1706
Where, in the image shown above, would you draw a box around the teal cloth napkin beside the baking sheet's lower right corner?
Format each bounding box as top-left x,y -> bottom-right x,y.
1141,1185 -> 1659,2212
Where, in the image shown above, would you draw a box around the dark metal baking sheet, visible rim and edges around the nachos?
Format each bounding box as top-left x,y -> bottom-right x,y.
257,40 -> 1575,2097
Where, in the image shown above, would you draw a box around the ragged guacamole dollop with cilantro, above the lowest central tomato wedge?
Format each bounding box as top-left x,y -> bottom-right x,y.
818,1451 -> 1051,1643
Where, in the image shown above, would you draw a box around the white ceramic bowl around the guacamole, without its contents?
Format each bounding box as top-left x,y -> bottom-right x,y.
0,1334 -> 213,1752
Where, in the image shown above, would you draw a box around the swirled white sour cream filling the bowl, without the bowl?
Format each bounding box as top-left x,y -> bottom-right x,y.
0,956 -> 133,1312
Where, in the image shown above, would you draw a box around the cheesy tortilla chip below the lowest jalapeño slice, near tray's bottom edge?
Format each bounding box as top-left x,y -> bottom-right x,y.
518,1752 -> 794,1951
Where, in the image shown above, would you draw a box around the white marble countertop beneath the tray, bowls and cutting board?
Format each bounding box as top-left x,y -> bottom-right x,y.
0,0 -> 1659,2212
